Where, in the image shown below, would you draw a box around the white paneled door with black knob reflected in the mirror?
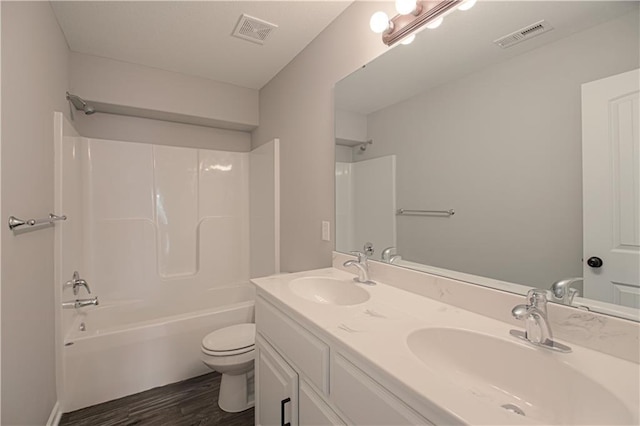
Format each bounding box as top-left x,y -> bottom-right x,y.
582,70 -> 640,307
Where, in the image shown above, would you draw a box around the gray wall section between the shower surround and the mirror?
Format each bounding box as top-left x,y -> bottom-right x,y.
252,2 -> 393,272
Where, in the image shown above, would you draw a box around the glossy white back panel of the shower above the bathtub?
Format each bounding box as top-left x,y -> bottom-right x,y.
79,138 -> 249,303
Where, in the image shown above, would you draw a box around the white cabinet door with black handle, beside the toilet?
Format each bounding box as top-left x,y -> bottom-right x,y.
256,334 -> 298,426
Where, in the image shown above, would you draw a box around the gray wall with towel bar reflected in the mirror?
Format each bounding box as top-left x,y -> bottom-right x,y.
363,13 -> 640,287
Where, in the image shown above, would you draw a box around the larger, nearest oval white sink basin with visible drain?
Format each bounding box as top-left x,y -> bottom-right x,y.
407,328 -> 637,425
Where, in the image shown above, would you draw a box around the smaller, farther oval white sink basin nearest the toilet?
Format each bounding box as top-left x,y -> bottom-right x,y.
289,277 -> 369,306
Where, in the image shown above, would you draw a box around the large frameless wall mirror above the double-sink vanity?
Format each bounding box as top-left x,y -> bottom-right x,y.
335,1 -> 640,320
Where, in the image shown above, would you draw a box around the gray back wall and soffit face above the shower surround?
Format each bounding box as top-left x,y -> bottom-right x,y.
67,52 -> 252,152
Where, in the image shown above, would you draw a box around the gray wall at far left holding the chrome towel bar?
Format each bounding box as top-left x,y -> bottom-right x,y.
0,1 -> 68,425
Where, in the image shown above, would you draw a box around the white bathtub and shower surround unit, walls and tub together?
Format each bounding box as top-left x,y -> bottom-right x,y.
56,114 -> 254,411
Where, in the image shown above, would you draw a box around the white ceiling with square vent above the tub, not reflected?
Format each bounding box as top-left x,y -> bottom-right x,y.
52,0 -> 353,89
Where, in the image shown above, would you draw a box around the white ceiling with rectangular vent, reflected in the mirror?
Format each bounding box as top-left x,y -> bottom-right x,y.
335,0 -> 640,115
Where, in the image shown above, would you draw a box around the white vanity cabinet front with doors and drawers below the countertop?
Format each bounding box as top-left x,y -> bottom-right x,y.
256,295 -> 432,426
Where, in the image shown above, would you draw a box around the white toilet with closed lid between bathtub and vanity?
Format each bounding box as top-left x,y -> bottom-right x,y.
202,324 -> 256,413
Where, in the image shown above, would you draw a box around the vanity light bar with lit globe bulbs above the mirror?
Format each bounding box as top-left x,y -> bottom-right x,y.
369,0 -> 477,46
